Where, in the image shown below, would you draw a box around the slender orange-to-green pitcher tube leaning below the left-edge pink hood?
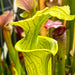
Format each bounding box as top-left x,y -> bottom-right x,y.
3,27 -> 25,75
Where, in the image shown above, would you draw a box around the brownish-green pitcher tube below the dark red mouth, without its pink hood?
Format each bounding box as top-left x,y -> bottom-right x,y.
54,32 -> 66,75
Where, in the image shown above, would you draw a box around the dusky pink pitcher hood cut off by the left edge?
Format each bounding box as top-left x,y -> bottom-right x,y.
0,11 -> 13,27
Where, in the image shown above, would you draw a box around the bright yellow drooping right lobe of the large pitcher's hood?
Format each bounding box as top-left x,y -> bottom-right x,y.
47,6 -> 75,20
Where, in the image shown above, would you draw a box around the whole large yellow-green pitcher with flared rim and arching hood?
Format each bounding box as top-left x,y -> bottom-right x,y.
10,6 -> 74,75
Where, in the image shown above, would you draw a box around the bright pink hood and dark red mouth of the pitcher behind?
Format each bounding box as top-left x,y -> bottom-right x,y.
45,19 -> 66,36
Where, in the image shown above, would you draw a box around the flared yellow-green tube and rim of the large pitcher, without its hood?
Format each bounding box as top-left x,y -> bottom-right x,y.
15,36 -> 58,75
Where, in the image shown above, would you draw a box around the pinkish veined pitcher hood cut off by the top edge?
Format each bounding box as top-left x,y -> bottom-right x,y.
16,0 -> 36,12
